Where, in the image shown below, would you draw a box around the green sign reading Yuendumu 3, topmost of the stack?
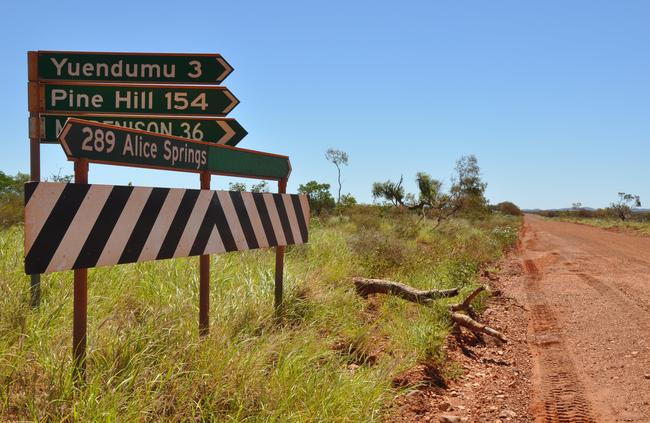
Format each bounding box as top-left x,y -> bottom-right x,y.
37,51 -> 233,84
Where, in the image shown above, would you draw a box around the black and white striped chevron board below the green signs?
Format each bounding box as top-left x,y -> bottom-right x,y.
25,182 -> 309,274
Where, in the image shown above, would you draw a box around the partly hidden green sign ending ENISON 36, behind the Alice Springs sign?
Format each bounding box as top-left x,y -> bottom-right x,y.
41,115 -> 248,146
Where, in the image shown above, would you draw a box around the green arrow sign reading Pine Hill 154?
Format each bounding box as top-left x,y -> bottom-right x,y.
36,82 -> 239,116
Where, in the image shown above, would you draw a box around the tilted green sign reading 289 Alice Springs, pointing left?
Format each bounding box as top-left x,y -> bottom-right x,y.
59,119 -> 291,180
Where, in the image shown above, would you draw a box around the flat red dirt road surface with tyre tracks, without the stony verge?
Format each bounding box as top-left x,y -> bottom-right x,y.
517,215 -> 650,422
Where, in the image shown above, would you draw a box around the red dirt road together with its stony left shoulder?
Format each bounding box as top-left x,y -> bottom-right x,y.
393,215 -> 650,422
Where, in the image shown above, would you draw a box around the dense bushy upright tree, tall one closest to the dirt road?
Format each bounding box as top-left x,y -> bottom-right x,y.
449,154 -> 488,216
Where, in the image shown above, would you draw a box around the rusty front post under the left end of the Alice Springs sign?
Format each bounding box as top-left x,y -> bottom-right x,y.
72,159 -> 88,381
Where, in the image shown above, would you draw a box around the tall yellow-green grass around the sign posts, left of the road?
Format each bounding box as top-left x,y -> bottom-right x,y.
0,208 -> 520,422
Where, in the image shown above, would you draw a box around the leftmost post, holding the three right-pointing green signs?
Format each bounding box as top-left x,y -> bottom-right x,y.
27,51 -> 41,308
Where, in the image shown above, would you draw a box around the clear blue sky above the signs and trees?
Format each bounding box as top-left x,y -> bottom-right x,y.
0,0 -> 650,208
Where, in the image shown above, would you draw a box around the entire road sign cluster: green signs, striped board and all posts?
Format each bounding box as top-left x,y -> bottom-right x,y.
25,51 -> 309,375
